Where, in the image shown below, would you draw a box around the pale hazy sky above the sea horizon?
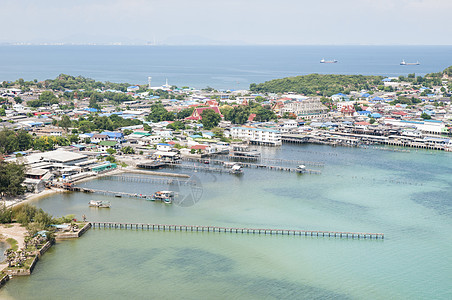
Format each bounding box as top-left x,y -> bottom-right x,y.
0,0 -> 452,45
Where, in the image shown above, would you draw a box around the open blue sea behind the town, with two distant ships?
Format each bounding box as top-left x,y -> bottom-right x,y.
0,46 -> 452,89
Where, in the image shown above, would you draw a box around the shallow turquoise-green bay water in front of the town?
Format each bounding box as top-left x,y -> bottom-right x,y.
0,145 -> 452,299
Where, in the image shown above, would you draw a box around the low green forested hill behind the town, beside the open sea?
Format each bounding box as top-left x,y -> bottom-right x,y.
250,74 -> 383,96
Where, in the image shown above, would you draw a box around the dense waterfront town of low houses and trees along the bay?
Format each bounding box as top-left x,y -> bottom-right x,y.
0,67 -> 452,284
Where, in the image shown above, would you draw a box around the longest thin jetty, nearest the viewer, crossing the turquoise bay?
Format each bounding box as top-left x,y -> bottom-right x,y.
90,221 -> 384,239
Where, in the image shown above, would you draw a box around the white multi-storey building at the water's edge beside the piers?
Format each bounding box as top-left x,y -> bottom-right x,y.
231,127 -> 282,146
